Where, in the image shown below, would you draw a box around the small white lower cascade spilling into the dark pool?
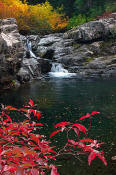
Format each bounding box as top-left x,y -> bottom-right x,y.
49,63 -> 76,78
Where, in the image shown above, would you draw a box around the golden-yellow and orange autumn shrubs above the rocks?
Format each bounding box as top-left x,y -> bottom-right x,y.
0,0 -> 68,33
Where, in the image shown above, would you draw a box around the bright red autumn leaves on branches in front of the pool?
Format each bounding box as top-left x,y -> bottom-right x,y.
0,99 -> 107,175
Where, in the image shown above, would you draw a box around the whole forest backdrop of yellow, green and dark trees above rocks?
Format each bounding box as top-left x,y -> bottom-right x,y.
0,0 -> 116,34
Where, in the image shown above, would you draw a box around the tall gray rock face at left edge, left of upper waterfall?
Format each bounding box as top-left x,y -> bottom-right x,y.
0,18 -> 24,86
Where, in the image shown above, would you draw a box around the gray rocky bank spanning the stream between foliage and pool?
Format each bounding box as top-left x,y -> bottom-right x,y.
0,15 -> 116,89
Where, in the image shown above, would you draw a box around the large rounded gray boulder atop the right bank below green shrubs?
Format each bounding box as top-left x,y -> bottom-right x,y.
64,21 -> 110,42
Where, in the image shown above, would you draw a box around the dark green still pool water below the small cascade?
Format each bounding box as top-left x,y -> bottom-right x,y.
0,79 -> 116,175
